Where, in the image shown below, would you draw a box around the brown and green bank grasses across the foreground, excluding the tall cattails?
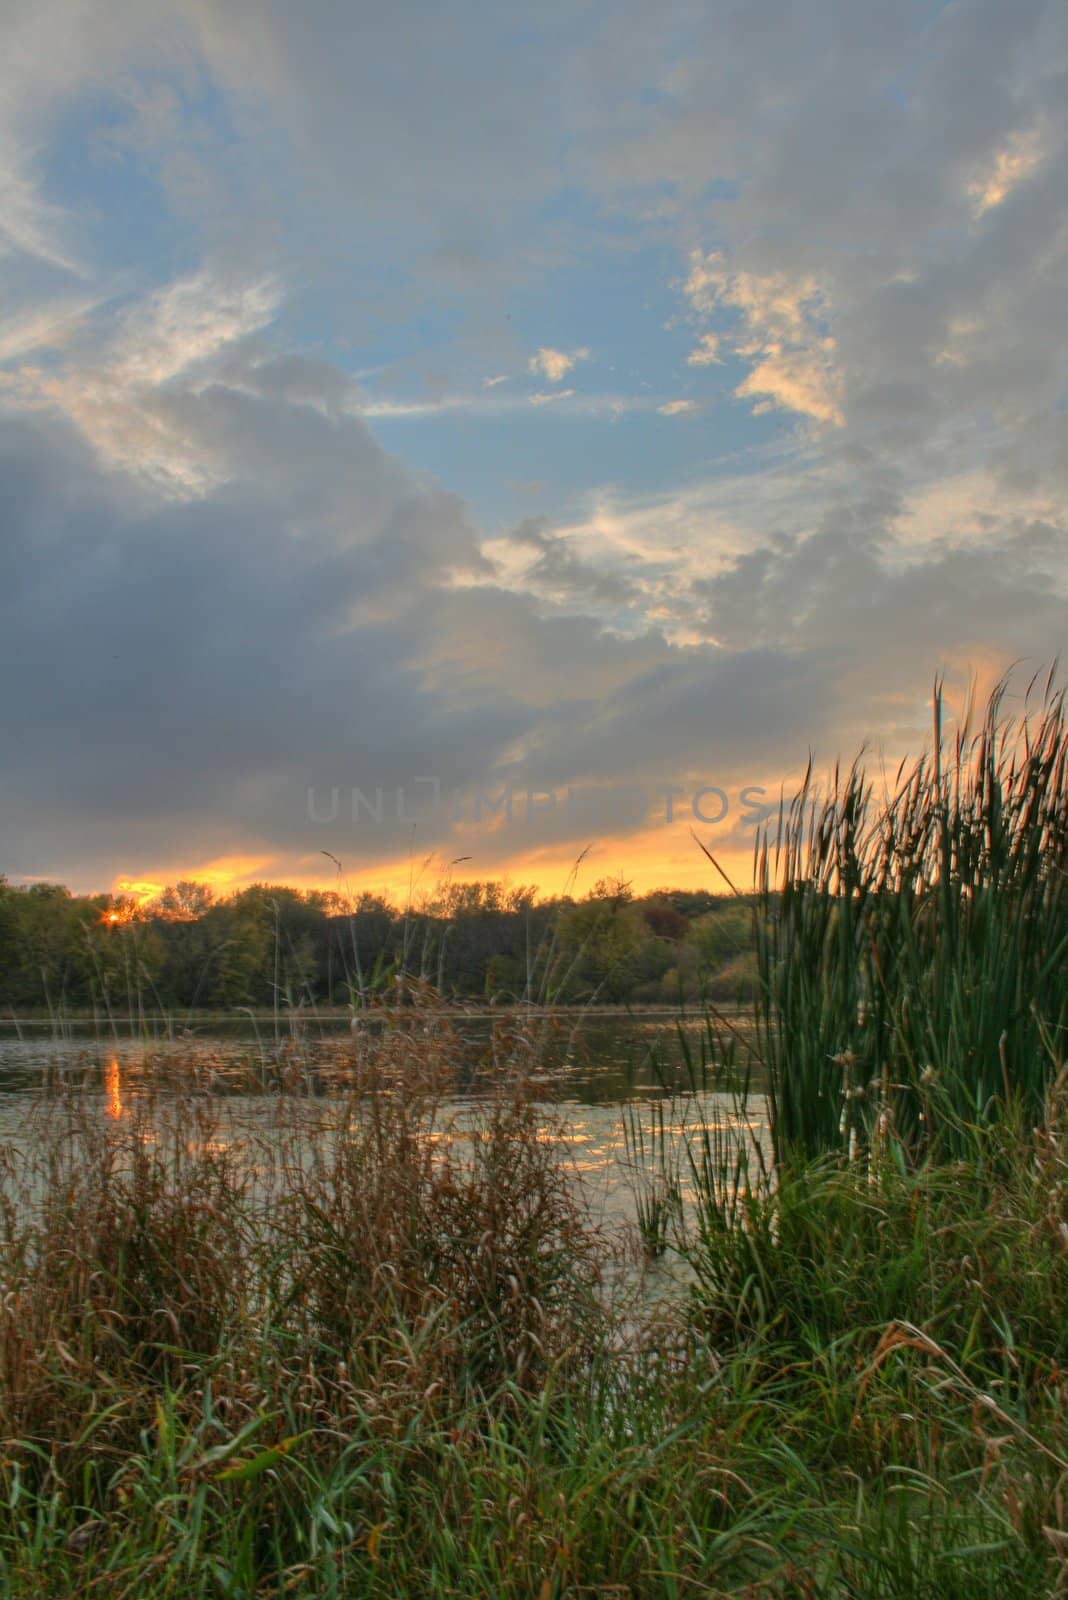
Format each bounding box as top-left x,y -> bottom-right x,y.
0,995 -> 1068,1600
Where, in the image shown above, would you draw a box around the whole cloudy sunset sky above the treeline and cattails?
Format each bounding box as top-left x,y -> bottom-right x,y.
0,0 -> 1068,894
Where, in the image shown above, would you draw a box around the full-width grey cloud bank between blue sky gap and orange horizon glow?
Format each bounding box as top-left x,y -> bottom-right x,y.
0,316 -> 1068,883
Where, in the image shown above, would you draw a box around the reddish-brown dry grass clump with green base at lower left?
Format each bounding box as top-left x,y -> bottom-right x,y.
0,1002 -> 626,1595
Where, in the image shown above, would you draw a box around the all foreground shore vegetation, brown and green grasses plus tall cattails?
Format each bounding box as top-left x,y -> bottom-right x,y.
0,681 -> 1068,1600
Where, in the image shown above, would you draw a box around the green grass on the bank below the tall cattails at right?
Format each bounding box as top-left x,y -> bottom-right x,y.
691,1080 -> 1068,1597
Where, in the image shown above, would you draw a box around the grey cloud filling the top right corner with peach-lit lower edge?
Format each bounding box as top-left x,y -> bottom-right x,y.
582,0 -> 1068,460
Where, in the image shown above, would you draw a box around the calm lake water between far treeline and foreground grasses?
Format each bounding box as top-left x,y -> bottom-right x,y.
0,1011 -> 767,1248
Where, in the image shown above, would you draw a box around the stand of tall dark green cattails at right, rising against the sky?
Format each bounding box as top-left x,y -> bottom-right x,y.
756,682 -> 1068,1158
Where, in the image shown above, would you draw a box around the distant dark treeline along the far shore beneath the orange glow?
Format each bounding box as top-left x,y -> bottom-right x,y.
0,877 -> 753,1014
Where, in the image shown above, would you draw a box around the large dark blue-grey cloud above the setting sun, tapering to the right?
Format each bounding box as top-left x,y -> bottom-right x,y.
0,313 -> 869,883
